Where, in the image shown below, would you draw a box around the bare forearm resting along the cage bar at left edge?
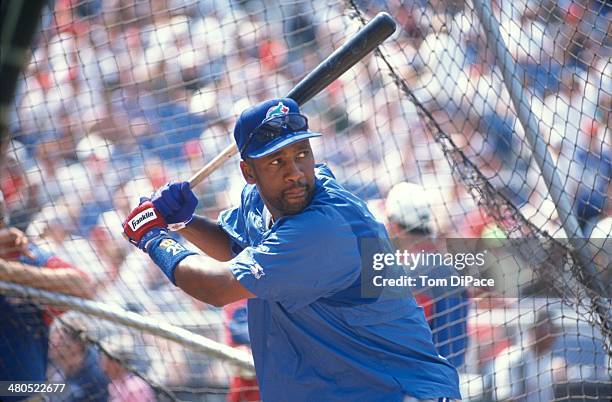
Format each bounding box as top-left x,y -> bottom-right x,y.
0,259 -> 93,299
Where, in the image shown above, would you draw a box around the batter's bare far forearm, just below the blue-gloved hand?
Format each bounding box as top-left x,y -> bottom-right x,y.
179,215 -> 233,261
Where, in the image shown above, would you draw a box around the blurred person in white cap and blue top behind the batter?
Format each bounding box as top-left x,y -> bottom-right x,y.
385,182 -> 468,367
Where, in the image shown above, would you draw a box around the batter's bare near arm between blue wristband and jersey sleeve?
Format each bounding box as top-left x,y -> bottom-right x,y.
174,255 -> 255,307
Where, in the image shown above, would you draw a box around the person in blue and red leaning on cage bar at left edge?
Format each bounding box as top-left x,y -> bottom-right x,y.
0,193 -> 93,400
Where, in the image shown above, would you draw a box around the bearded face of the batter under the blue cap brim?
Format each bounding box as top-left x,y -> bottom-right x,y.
241,140 -> 315,218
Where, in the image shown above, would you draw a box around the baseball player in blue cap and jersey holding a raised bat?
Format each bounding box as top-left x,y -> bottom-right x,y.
124,98 -> 461,402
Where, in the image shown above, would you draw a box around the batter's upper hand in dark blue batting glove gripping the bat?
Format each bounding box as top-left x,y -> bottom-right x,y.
151,181 -> 198,230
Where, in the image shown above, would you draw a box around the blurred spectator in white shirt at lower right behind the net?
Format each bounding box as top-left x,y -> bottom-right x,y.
493,309 -> 566,402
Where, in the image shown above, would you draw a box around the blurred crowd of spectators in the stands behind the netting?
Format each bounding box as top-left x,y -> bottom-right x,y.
0,0 -> 612,400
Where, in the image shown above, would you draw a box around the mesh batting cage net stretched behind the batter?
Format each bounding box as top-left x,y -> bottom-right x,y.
0,0 -> 612,401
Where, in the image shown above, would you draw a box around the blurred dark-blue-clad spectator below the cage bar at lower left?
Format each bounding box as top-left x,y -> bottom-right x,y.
49,314 -> 109,402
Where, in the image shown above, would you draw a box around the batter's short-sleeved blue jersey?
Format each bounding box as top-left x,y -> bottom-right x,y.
219,166 -> 461,402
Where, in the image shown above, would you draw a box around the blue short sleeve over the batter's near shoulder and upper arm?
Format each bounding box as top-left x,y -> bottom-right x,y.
230,210 -> 361,311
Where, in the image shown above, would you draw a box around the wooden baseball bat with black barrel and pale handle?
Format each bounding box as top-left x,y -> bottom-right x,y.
189,12 -> 396,188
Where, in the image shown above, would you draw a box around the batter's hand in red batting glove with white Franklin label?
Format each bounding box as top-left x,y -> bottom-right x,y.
123,198 -> 167,251
